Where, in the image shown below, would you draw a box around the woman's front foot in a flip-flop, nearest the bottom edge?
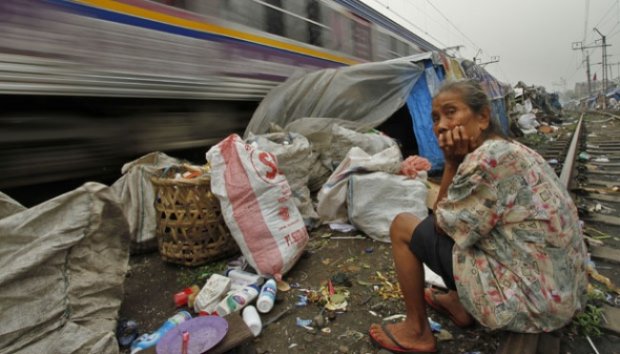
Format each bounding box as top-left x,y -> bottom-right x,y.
369,321 -> 437,353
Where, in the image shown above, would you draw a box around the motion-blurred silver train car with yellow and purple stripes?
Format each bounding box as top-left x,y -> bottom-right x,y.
0,0 -> 438,189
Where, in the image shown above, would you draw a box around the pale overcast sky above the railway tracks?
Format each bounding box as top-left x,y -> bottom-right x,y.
363,0 -> 620,91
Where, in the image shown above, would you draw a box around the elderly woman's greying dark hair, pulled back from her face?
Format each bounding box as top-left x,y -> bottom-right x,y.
435,79 -> 507,139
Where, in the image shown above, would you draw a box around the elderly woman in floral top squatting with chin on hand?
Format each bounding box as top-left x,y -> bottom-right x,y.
370,80 -> 587,352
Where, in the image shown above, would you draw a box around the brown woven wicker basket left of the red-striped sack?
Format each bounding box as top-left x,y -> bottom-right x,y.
151,175 -> 239,266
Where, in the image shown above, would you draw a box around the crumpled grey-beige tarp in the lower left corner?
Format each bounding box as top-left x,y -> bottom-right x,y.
0,183 -> 129,353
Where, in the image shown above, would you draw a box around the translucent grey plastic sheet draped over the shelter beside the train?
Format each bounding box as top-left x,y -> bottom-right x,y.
244,53 -> 434,137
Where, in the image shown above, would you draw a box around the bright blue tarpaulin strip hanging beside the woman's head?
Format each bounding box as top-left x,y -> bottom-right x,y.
407,71 -> 444,172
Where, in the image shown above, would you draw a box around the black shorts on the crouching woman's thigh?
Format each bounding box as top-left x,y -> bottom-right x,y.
409,215 -> 456,290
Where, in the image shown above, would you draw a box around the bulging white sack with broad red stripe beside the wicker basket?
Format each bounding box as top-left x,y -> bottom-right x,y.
207,134 -> 308,278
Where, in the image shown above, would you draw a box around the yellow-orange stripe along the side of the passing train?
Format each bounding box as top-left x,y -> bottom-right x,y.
74,0 -> 359,65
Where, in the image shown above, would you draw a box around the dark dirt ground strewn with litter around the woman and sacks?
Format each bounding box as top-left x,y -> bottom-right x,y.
120,227 -> 620,354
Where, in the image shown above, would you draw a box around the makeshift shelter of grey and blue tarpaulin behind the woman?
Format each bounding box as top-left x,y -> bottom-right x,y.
245,52 -> 508,170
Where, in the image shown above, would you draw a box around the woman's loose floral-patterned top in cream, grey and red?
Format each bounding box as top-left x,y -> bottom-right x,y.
436,139 -> 587,332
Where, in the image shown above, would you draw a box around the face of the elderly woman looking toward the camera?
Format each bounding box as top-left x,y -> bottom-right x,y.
431,90 -> 489,141
